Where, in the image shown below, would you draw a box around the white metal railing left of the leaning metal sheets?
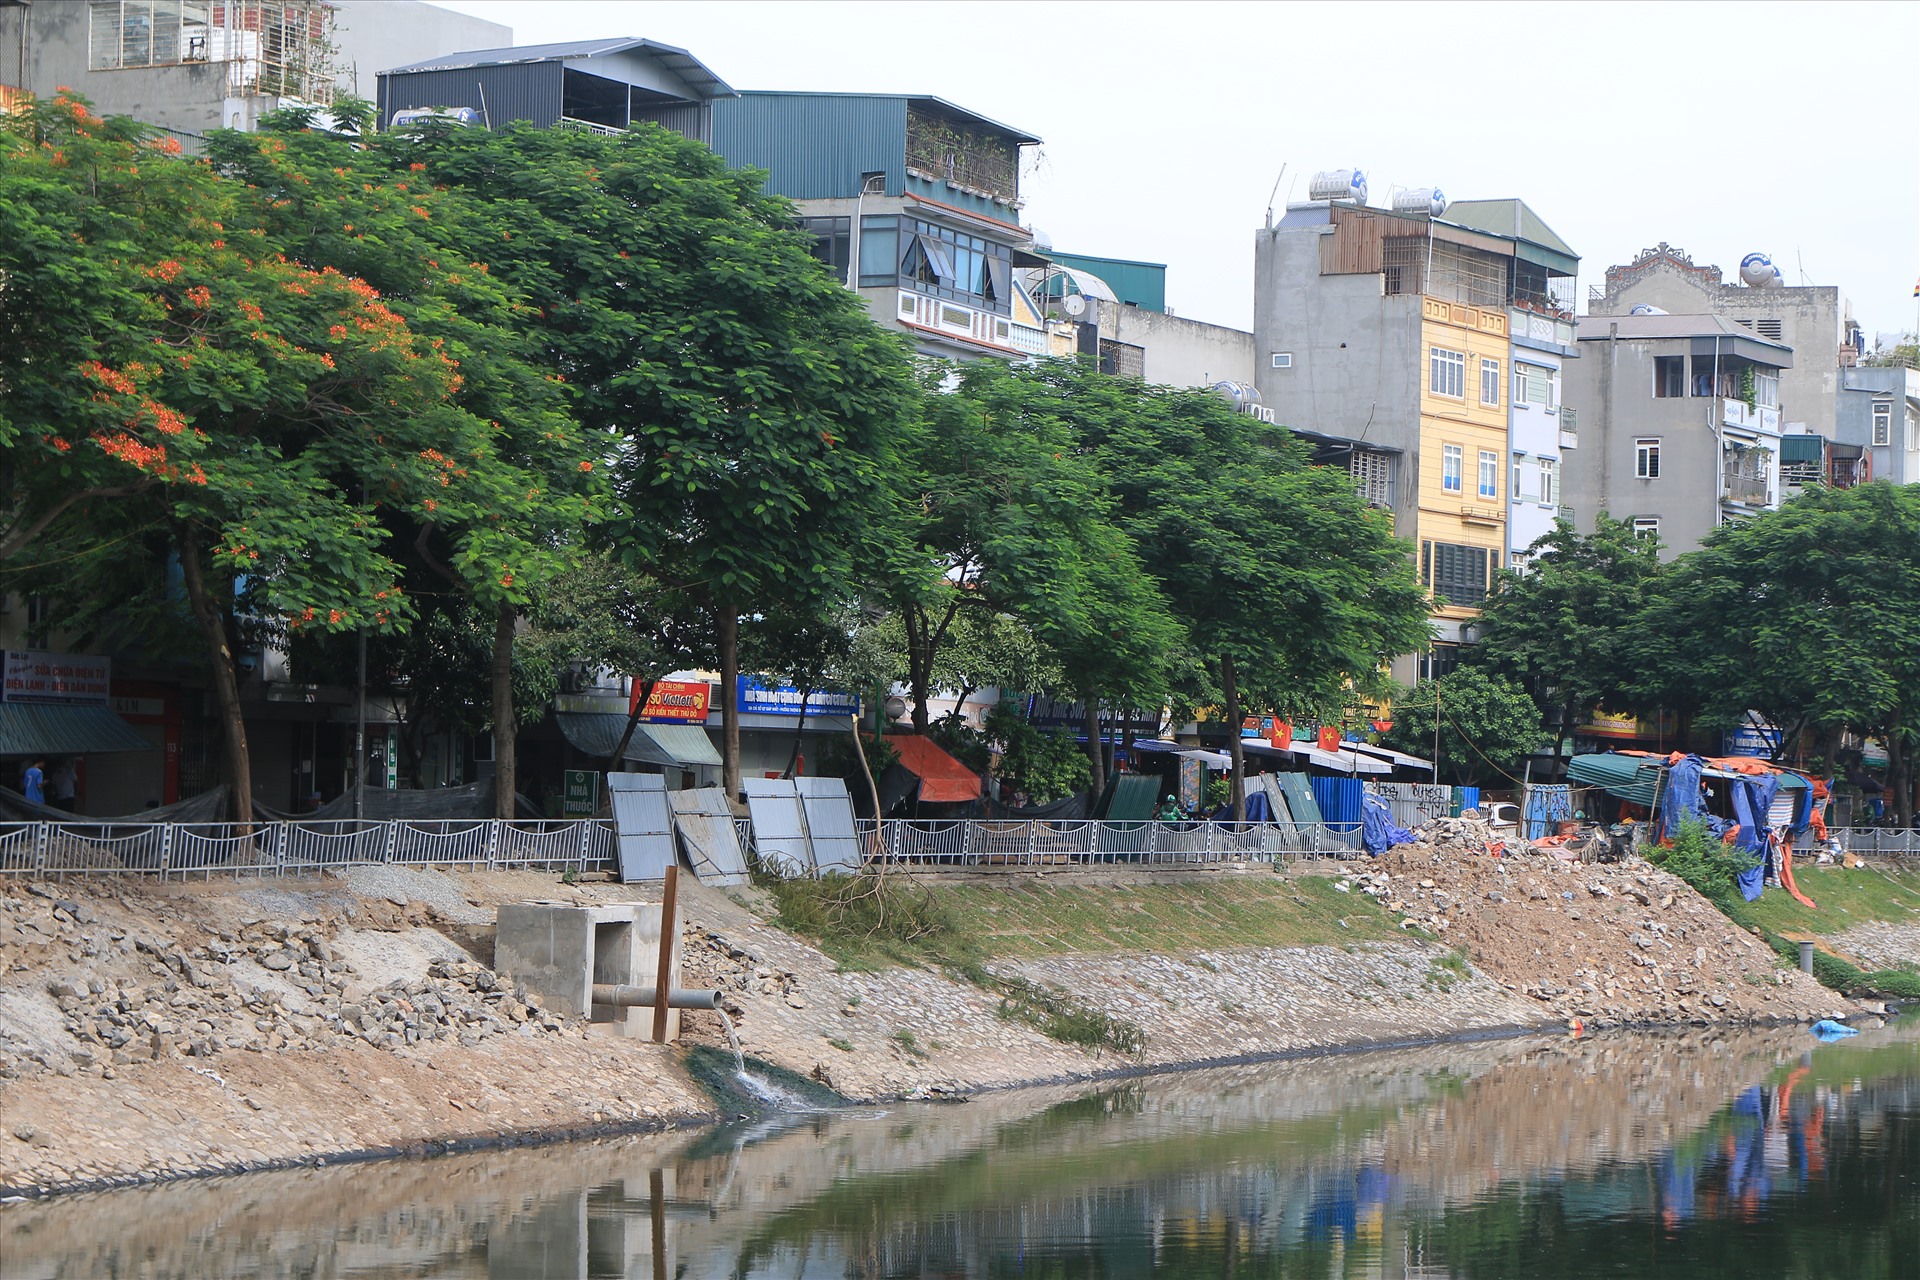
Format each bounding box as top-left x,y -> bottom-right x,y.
0,818 -> 614,879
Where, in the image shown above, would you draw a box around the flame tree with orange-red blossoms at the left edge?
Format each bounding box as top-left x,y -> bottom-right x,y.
0,92 -> 588,819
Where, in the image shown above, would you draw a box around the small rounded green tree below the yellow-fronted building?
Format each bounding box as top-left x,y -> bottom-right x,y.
1380,666 -> 1548,787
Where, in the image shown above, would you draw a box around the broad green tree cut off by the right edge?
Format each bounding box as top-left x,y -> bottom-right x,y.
1642,482 -> 1920,823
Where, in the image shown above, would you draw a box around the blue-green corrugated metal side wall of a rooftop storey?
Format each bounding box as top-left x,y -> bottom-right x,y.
712,92 -> 906,200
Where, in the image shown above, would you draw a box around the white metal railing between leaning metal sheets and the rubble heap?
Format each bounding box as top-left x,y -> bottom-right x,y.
854,818 -> 1359,869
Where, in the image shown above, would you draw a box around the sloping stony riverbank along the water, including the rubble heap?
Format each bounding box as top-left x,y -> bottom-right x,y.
0,825 -> 1866,1192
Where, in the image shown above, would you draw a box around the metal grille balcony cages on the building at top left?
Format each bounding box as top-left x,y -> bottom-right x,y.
86,0 -> 334,104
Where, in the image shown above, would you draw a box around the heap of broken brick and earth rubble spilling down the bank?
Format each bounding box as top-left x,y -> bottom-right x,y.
1336,810 -> 1841,1027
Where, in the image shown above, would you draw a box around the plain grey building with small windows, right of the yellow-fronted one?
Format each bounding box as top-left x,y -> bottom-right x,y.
1565,315 -> 1793,558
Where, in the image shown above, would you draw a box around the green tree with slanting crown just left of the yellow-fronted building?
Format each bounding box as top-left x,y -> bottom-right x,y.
1060,368 -> 1428,819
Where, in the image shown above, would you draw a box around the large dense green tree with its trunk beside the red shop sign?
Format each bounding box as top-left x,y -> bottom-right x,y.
382,125 -> 912,791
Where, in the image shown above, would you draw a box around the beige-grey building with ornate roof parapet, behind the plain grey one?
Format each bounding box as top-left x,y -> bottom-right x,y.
1586,242 -> 1862,439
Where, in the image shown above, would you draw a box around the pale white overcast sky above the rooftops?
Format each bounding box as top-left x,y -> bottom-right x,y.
438,0 -> 1920,340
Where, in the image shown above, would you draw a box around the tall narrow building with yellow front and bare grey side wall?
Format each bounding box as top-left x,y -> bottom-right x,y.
1254,192 -> 1576,681
